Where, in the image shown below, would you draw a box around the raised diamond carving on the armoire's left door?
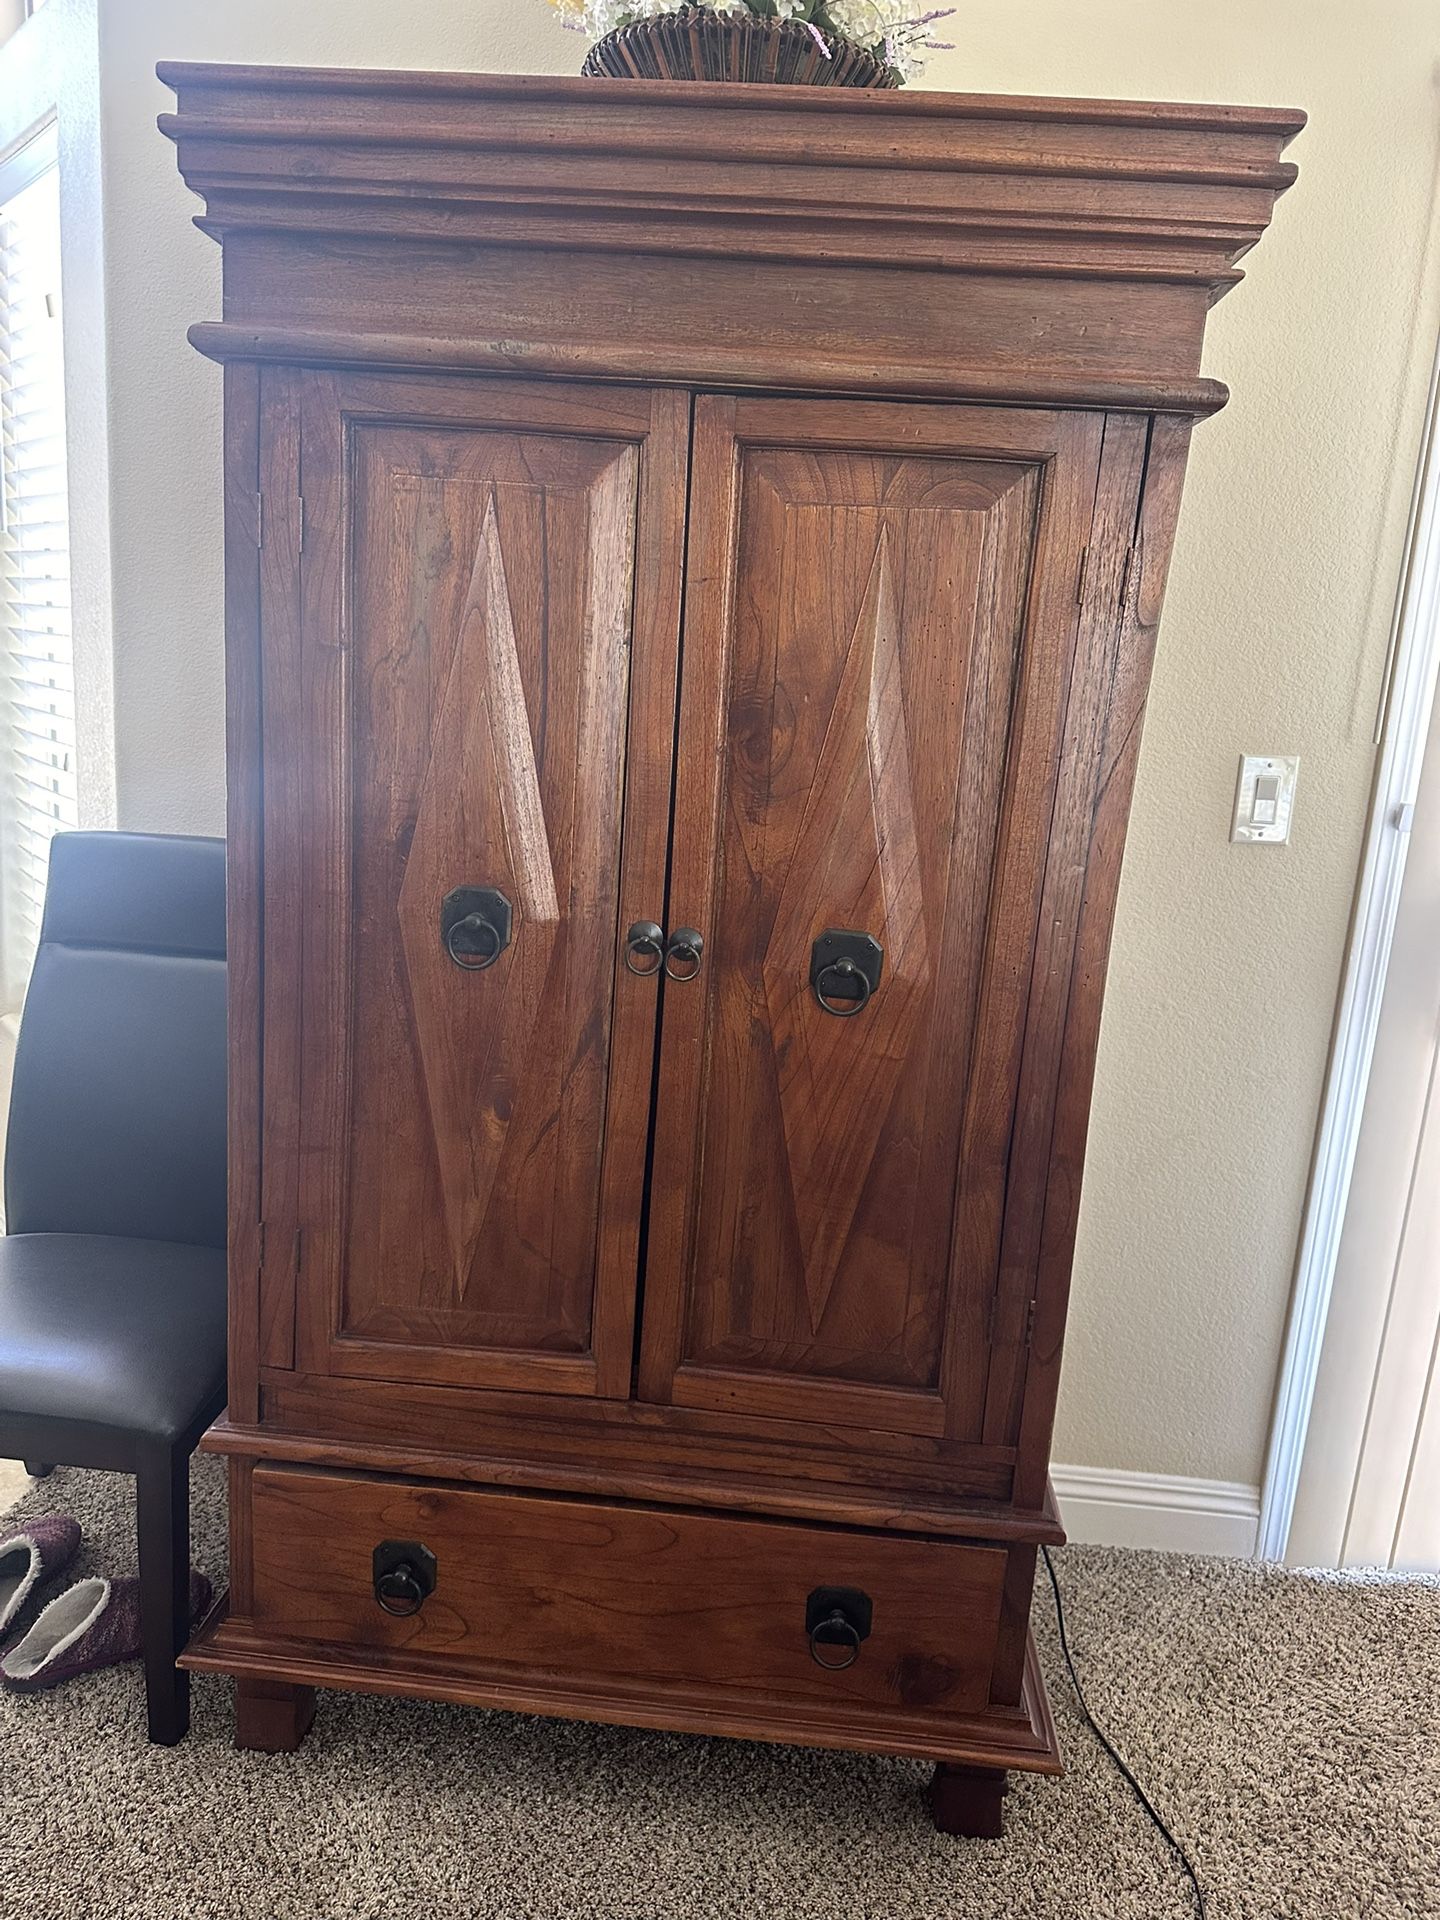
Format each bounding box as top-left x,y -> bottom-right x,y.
396,490 -> 561,1300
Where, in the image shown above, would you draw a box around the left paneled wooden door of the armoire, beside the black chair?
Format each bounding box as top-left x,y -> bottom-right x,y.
263,372 -> 687,1394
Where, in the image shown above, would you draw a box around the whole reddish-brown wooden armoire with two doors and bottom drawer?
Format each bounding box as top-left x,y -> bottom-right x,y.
161,65 -> 1304,1834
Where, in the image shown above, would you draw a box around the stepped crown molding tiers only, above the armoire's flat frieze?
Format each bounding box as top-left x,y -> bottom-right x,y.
159,63 -> 1304,298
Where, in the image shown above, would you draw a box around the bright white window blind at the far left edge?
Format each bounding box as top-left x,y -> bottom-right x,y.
0,129 -> 79,1012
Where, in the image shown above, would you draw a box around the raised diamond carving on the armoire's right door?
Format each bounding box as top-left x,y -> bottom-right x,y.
762,524 -> 931,1331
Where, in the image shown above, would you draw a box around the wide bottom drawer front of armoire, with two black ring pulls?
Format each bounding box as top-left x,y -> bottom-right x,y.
252,1467 -> 1006,1713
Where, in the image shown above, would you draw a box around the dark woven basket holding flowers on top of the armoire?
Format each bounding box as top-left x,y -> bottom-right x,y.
580,6 -> 900,86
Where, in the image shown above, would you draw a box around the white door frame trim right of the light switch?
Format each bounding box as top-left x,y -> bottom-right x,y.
1258,330 -> 1440,1559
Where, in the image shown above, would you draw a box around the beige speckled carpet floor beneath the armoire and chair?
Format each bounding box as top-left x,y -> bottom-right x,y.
0,1461 -> 1440,1920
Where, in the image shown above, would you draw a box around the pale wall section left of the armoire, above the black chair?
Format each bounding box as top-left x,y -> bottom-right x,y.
93,0 -> 568,833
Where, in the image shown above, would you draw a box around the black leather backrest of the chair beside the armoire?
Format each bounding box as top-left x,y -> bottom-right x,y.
6,833 -> 225,1246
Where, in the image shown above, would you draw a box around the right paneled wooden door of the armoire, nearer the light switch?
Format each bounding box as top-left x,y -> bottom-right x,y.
641,396 -> 1104,1440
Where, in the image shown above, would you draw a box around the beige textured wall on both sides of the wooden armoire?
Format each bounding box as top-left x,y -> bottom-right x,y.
25,0 -> 1440,1482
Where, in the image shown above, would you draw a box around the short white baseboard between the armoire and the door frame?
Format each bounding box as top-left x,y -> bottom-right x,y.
1050,1467 -> 1260,1559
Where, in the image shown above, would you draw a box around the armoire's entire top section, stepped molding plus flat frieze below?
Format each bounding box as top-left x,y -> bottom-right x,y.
159,63 -> 1304,415
